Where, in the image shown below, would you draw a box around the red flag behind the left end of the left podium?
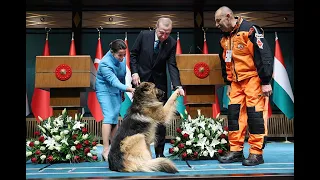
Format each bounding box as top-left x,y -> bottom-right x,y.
31,32 -> 53,122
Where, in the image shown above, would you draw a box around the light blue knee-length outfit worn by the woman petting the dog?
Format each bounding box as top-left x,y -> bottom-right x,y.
95,51 -> 127,124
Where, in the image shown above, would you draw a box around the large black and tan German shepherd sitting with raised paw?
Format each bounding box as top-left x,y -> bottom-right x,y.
108,82 -> 178,173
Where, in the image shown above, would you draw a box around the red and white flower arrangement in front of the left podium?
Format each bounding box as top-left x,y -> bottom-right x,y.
26,109 -> 98,164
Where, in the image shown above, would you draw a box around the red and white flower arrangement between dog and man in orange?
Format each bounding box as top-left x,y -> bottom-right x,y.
169,110 -> 229,160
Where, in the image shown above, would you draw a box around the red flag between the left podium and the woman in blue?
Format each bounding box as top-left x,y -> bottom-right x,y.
87,32 -> 103,122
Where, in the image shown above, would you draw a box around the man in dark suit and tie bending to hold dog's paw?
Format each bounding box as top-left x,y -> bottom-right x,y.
130,18 -> 184,157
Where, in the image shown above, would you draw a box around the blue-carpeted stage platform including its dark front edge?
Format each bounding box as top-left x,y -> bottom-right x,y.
26,142 -> 294,180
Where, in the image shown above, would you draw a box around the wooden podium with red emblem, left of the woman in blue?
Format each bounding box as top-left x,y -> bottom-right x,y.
35,55 -> 96,117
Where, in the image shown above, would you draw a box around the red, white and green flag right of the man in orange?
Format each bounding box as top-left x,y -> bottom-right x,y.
272,33 -> 294,119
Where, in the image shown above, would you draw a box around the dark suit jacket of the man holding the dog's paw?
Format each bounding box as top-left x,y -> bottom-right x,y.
130,30 -> 181,92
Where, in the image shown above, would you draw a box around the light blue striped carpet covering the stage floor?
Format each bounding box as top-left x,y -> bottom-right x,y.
26,142 -> 294,179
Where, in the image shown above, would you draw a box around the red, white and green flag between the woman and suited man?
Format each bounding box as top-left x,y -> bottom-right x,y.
120,33 -> 132,118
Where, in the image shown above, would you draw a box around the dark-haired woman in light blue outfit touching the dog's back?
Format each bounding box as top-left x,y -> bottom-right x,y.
96,39 -> 134,160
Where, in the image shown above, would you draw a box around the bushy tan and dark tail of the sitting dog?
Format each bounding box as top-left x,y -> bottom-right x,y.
139,157 -> 179,173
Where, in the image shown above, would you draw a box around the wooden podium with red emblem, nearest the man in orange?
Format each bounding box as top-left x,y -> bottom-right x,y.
176,54 -> 225,118
